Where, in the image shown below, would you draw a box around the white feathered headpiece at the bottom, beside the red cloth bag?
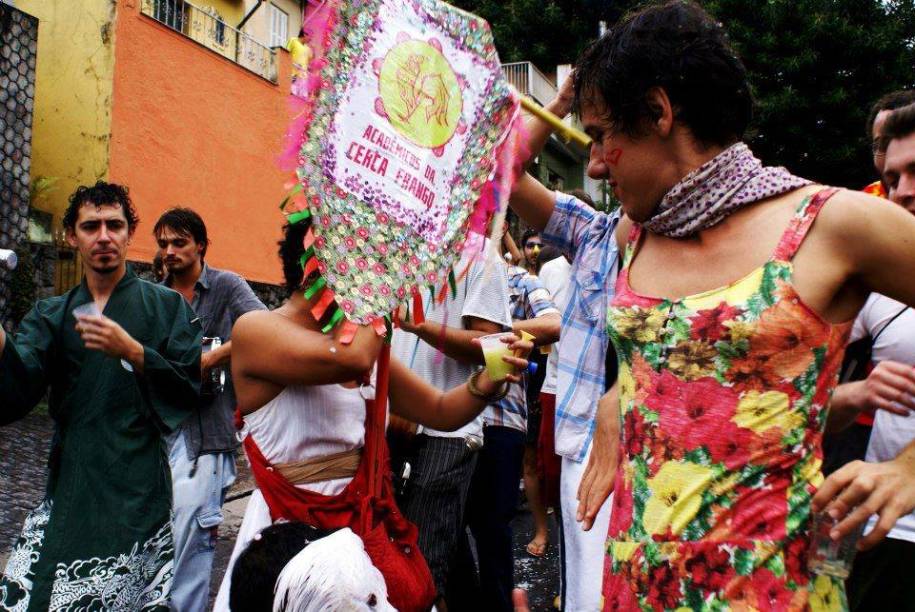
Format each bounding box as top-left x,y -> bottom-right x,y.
273,529 -> 397,612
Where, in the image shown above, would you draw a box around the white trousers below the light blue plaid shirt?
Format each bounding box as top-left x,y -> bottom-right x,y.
559,449 -> 613,612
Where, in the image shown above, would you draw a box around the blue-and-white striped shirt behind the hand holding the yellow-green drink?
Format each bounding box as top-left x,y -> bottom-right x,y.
483,266 -> 559,431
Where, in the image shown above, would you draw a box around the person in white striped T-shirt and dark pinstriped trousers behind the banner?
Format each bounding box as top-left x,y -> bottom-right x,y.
392,234 -> 512,610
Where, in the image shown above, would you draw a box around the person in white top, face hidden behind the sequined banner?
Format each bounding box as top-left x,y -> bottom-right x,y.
215,223 -> 533,610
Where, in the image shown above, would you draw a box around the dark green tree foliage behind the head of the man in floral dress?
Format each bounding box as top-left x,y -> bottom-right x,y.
453,0 -> 915,188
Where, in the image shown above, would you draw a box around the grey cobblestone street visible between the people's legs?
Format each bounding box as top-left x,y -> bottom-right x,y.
0,411 -> 559,612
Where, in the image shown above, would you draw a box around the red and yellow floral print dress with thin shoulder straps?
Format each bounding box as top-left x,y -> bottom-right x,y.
603,189 -> 850,611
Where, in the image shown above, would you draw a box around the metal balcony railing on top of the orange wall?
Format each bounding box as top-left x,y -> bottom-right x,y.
140,0 -> 277,83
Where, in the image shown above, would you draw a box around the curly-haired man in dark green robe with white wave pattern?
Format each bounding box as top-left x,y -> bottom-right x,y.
0,181 -> 201,611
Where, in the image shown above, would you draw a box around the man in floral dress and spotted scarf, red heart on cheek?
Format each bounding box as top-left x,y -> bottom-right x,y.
512,1 -> 915,609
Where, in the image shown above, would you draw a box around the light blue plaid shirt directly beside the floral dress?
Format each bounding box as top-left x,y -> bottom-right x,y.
542,193 -> 620,462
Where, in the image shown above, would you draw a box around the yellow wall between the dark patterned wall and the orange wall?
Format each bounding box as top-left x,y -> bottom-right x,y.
16,0 -> 117,224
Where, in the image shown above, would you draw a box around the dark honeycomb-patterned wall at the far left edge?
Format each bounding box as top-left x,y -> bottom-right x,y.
0,4 -> 38,329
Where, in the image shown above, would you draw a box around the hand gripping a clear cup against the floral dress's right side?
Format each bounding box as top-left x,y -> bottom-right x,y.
812,450 -> 915,550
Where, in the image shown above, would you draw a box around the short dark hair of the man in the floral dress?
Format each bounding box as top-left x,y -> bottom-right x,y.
573,0 -> 753,146
